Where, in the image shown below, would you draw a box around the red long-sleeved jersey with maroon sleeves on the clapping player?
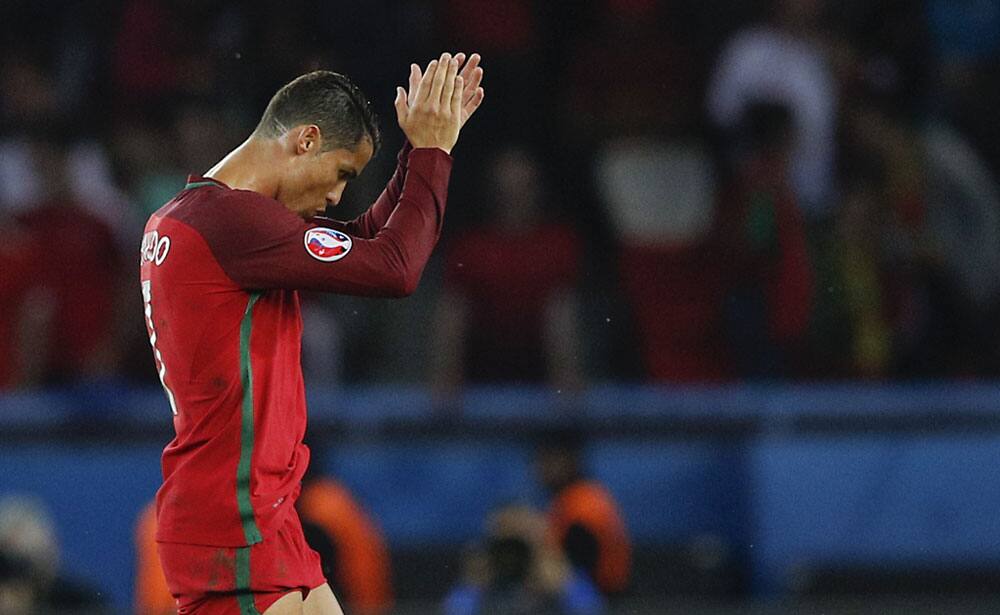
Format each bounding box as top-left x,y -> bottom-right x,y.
140,147 -> 451,547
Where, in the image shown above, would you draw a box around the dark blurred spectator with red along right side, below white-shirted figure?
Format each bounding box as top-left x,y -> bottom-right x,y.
719,104 -> 813,378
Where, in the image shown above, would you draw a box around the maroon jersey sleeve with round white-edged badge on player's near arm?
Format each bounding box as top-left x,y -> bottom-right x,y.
199,148 -> 452,297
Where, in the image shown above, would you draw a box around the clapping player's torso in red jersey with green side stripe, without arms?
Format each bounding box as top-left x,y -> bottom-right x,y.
141,181 -> 309,547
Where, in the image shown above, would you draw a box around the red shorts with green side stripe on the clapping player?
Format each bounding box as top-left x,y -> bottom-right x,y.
157,512 -> 326,615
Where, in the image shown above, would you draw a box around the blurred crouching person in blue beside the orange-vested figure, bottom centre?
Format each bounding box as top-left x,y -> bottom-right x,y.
444,505 -> 604,615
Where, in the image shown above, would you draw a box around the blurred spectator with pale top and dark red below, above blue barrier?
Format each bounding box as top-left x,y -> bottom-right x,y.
596,138 -> 730,382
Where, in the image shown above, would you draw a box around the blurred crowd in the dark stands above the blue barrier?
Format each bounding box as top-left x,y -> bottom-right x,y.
0,0 -> 1000,398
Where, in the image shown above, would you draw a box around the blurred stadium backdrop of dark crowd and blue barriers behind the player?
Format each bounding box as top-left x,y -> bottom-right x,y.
0,0 -> 1000,613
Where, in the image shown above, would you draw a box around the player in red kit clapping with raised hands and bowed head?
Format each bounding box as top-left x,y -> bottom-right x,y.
140,53 -> 483,615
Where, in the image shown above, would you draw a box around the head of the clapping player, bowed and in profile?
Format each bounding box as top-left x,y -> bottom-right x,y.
253,71 -> 381,218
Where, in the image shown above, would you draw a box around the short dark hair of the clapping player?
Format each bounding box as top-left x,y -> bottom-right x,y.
254,70 -> 382,152
